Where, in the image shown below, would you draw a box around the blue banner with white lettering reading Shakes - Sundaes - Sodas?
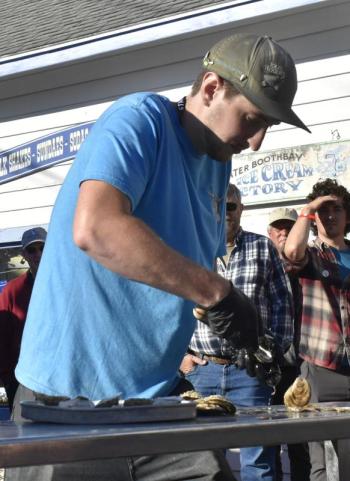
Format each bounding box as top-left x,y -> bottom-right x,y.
0,122 -> 94,184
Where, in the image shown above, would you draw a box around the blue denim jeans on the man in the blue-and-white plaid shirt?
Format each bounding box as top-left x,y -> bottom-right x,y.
186,361 -> 276,481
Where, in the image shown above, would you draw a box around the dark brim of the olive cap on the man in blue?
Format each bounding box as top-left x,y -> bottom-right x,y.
234,83 -> 311,134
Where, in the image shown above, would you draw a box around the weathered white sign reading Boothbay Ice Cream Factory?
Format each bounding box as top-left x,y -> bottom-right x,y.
231,140 -> 350,204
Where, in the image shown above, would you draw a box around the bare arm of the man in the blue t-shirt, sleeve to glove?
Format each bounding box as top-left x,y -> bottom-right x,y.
74,178 -> 230,306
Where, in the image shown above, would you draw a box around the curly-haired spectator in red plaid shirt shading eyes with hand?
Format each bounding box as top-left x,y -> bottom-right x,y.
284,179 -> 350,481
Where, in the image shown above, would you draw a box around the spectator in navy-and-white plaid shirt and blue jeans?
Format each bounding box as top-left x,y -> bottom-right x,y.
181,184 -> 293,481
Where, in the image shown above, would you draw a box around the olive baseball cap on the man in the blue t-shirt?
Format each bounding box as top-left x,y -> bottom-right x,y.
203,33 -> 310,132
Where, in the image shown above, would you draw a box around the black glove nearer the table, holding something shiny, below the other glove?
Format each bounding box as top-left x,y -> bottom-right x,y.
235,332 -> 281,388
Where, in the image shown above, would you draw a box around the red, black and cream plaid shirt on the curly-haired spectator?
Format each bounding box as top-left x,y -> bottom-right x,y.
293,238 -> 350,370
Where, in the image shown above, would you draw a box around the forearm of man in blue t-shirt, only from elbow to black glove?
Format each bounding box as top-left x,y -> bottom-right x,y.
83,216 -> 230,306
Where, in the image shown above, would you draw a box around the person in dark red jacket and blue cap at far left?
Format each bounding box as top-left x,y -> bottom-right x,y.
0,227 -> 46,410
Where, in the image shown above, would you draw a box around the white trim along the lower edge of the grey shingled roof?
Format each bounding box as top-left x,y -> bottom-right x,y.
0,0 -> 337,79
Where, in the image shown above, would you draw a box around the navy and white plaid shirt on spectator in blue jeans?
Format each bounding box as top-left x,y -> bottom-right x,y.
189,229 -> 293,357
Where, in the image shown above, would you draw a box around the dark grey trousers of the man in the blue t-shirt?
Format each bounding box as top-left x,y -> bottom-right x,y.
5,385 -> 235,481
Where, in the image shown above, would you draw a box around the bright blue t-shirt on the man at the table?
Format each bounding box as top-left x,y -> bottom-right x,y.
16,93 -> 231,400
